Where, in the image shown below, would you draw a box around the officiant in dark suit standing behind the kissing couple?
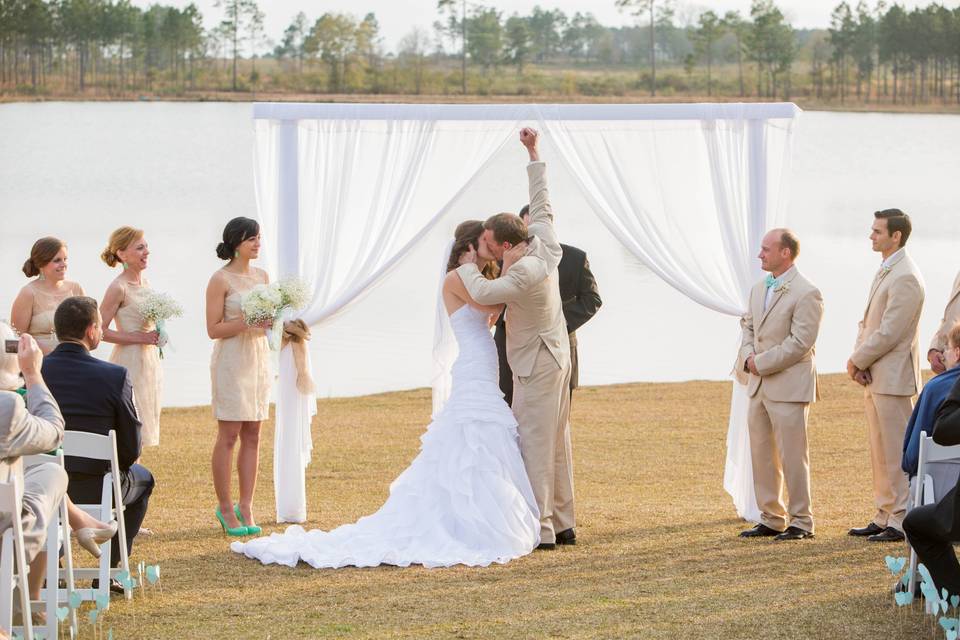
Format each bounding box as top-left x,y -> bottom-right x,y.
493,205 -> 603,404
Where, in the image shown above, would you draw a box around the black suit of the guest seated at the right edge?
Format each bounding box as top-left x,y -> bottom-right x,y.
903,370 -> 960,594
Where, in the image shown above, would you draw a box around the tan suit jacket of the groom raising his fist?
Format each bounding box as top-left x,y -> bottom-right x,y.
457,162 -> 570,378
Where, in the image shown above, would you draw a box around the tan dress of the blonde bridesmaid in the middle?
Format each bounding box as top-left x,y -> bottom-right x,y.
110,282 -> 163,447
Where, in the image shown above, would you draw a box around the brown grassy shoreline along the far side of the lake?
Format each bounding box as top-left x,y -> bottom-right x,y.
0,91 -> 960,115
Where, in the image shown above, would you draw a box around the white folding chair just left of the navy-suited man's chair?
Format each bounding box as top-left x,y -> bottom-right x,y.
22,449 -> 79,638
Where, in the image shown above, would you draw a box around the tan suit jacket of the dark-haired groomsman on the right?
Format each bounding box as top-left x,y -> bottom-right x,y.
850,251 -> 924,396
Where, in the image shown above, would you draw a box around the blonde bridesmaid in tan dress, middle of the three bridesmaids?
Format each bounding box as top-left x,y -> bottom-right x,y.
100,227 -> 163,447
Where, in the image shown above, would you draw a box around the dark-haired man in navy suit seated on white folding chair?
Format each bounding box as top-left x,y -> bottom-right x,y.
43,296 -> 154,567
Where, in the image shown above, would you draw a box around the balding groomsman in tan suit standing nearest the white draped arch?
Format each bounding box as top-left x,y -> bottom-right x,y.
738,229 -> 823,540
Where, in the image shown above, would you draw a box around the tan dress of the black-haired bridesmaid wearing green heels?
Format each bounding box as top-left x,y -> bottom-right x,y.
210,269 -> 270,422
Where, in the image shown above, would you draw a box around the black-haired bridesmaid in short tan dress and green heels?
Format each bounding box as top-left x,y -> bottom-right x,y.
207,218 -> 270,536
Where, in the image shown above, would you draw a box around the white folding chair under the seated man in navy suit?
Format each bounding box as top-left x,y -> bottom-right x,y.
63,430 -> 133,602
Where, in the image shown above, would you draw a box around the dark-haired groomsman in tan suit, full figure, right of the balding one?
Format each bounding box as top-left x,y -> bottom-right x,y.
847,209 -> 924,542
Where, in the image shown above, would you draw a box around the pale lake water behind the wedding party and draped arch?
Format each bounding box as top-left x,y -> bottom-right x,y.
0,103 -> 960,406
